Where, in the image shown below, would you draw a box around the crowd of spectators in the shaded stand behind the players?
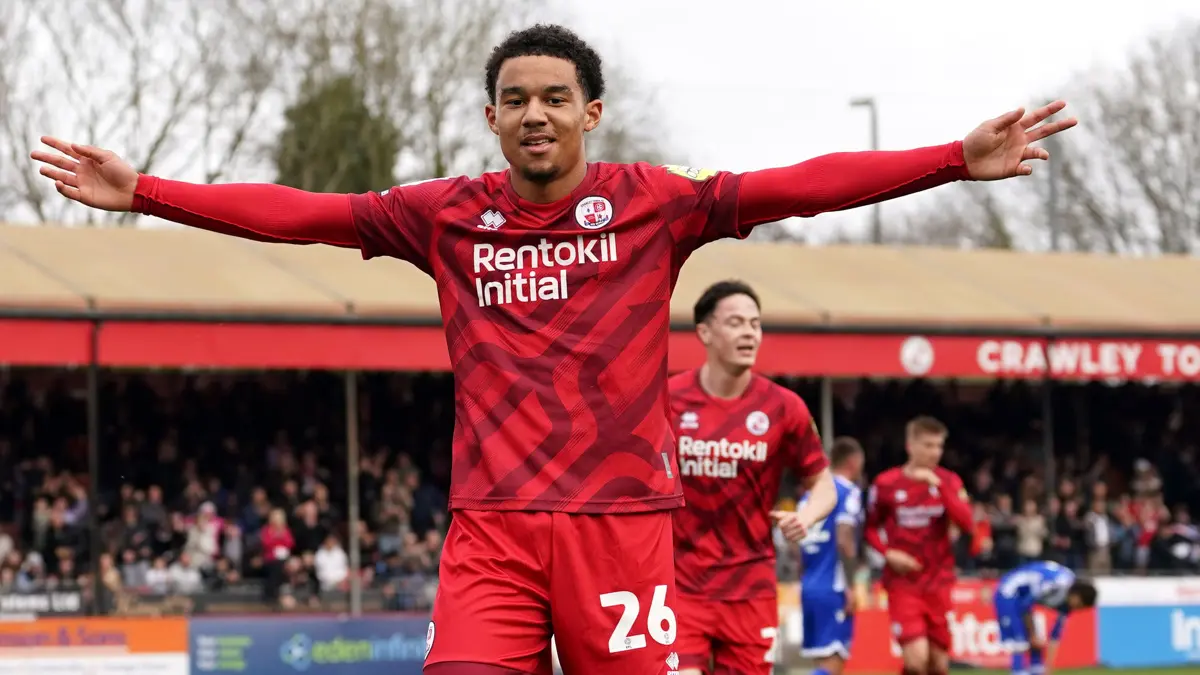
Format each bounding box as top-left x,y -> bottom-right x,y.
0,370 -> 1200,609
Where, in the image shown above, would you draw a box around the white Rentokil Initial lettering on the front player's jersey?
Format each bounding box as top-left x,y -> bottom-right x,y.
473,233 -> 617,307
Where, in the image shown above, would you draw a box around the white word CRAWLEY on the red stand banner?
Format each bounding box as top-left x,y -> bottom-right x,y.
976,340 -> 1142,377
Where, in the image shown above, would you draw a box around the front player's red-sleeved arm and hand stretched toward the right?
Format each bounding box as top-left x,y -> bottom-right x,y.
737,101 -> 1075,228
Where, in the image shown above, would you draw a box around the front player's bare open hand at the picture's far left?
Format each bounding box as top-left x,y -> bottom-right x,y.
30,136 -> 138,211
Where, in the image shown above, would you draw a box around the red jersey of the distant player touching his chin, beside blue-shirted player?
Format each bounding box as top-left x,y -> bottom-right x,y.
864,466 -> 971,589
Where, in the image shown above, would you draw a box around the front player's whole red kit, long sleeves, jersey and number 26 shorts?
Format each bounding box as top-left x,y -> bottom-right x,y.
133,142 -> 968,675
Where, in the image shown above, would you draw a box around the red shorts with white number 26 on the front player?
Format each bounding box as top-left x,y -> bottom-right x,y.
425,510 -> 676,675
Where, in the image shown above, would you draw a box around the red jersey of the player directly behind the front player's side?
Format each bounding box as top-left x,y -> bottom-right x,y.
670,369 -> 828,601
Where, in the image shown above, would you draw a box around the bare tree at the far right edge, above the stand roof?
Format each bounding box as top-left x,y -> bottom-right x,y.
1038,22 -> 1200,253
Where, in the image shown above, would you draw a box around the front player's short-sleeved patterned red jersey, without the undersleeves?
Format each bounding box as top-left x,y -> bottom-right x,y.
350,163 -> 750,513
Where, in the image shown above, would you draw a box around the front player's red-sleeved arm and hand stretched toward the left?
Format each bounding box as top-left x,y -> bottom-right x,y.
32,137 -> 359,249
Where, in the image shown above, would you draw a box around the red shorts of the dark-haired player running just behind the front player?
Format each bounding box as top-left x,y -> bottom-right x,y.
676,595 -> 779,675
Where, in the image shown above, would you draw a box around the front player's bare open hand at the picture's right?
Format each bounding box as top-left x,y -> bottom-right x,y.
962,101 -> 1079,180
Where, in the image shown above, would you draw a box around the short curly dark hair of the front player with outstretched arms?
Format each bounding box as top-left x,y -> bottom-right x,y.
484,24 -> 604,101
